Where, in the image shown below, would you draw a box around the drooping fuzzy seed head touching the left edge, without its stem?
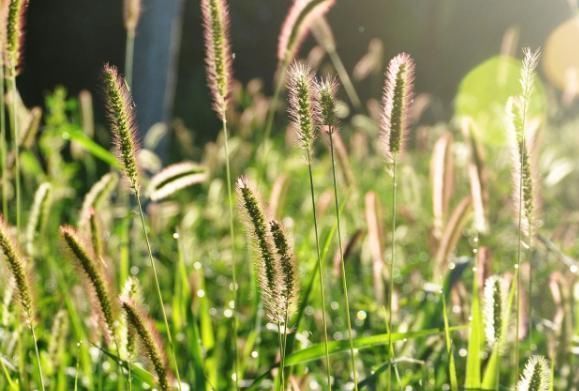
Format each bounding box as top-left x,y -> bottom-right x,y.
0,216 -> 33,324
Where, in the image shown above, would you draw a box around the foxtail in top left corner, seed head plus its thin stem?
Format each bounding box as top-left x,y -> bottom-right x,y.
4,0 -> 28,230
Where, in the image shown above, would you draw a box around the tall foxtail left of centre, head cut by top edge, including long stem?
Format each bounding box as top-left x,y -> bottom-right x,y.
201,0 -> 240,389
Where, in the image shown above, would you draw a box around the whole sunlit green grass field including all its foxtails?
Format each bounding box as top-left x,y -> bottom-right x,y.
0,0 -> 579,391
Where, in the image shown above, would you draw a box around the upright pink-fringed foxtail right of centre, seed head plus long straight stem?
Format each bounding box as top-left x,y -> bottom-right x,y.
381,53 -> 414,389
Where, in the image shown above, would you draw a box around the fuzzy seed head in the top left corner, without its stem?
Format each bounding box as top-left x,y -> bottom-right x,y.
5,0 -> 28,76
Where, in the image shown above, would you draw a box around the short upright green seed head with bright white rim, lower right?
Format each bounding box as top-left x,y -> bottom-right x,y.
484,276 -> 507,349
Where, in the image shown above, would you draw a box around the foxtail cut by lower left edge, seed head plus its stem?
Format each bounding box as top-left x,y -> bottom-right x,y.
0,216 -> 45,391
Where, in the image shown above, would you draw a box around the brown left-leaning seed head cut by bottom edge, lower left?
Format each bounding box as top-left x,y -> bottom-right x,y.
121,298 -> 170,390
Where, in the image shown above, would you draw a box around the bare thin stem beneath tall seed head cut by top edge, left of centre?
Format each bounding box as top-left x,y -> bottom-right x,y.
221,112 -> 239,390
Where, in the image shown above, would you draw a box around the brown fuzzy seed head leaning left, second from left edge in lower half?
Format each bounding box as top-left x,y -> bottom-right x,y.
60,226 -> 115,344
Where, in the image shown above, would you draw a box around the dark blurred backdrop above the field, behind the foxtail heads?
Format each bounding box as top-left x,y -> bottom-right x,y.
19,0 -> 577,143
